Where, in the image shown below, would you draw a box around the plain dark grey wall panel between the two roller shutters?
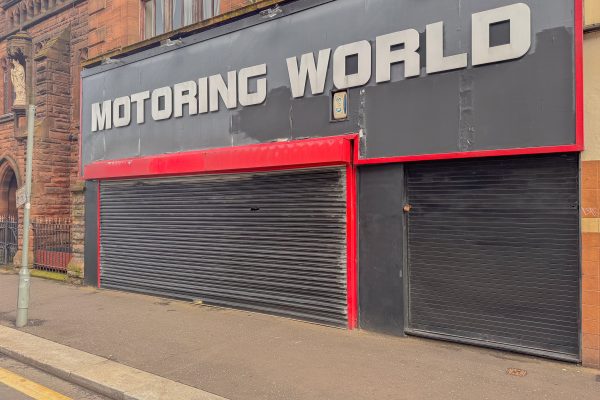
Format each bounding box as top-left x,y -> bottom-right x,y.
358,164 -> 404,335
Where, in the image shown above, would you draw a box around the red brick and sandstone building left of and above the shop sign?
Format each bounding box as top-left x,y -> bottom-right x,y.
0,0 -> 255,274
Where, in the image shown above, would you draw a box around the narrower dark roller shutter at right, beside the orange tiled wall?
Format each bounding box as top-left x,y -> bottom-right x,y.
407,154 -> 580,361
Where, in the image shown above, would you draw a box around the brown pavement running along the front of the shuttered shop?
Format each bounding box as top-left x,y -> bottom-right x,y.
0,273 -> 600,400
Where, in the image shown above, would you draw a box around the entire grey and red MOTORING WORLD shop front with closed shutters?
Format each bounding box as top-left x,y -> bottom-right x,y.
81,0 -> 583,361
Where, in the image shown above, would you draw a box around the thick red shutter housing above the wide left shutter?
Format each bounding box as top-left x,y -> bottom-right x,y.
84,135 -> 356,179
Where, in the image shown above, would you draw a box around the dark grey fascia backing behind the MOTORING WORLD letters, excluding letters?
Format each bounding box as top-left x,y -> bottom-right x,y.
82,0 -> 575,164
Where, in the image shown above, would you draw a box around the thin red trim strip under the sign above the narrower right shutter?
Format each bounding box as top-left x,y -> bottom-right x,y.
355,144 -> 583,165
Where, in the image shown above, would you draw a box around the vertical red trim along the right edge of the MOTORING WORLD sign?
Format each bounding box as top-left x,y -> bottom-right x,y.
575,0 -> 585,150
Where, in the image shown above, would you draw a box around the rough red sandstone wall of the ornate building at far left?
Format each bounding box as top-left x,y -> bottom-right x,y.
0,1 -> 88,263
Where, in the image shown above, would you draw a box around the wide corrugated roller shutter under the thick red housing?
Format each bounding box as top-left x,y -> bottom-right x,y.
100,168 -> 347,326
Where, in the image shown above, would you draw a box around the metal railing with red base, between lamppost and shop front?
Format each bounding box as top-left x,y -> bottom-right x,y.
32,219 -> 73,273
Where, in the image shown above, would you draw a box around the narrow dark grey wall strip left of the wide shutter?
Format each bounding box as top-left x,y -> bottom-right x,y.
83,181 -> 98,286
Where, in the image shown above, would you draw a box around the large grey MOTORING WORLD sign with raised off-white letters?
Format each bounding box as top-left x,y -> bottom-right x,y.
82,0 -> 576,163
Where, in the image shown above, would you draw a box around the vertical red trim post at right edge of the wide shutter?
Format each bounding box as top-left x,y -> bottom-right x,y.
346,161 -> 358,329
